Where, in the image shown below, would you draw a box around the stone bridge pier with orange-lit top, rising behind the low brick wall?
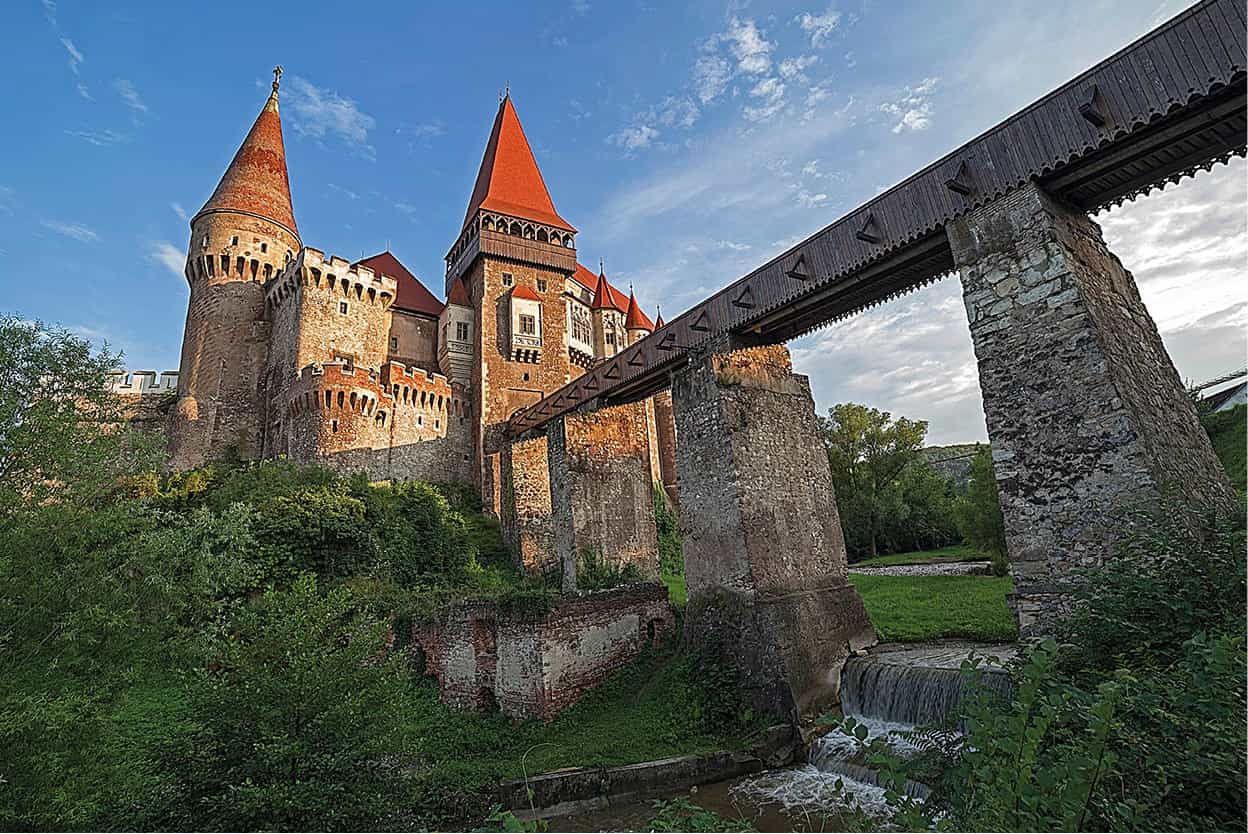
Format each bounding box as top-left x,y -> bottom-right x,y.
545,402 -> 659,591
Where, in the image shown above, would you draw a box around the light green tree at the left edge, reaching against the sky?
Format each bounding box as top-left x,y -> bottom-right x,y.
0,316 -> 155,519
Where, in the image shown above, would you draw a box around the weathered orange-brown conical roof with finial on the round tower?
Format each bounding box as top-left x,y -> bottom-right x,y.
191,69 -> 300,237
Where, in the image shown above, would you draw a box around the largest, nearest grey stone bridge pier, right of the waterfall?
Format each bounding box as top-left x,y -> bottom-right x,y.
948,185 -> 1236,637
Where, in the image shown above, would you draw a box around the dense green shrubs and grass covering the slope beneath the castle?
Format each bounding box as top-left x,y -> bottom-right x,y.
0,321 -> 755,830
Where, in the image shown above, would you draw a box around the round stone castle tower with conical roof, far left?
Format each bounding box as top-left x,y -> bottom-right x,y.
170,67 -> 302,469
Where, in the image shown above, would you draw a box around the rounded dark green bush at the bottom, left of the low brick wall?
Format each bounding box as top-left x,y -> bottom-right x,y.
160,574 -> 412,830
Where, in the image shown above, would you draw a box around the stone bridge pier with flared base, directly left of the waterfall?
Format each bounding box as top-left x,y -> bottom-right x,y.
671,340 -> 875,720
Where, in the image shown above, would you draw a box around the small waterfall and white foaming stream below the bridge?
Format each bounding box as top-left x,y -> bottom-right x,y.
733,644 -> 1013,817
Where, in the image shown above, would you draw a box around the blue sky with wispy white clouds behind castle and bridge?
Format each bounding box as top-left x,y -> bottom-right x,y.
0,0 -> 1248,442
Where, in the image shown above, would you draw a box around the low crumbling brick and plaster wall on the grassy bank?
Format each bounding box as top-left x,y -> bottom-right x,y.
411,583 -> 673,720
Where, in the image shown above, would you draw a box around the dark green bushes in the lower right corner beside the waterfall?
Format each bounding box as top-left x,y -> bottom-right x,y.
833,506 -> 1248,832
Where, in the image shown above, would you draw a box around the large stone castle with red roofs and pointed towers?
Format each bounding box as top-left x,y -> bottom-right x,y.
164,67 -> 675,514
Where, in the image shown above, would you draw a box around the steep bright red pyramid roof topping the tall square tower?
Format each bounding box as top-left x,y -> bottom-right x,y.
464,96 -> 577,232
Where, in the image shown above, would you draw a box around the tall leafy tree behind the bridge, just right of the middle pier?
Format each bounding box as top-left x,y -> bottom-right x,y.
819,402 -> 927,556
